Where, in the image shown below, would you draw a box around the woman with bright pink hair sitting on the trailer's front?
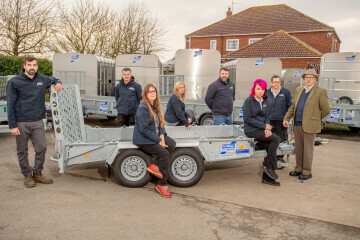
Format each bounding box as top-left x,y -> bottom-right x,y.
242,79 -> 280,186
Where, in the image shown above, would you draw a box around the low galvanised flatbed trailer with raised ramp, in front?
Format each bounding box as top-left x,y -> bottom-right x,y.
51,85 -> 294,187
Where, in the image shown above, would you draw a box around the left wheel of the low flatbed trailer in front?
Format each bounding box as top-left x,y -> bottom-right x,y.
113,149 -> 151,188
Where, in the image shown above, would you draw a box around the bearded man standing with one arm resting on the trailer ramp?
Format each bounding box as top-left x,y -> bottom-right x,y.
6,56 -> 62,187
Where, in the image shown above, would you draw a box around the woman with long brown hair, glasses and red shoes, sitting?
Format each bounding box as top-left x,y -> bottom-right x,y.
133,84 -> 176,197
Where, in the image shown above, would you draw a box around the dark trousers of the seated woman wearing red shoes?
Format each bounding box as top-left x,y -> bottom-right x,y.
138,135 -> 176,186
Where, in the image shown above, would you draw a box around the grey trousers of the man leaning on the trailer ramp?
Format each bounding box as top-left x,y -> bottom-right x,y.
16,120 -> 46,176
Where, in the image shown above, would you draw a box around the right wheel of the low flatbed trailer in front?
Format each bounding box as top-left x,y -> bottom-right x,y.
169,148 -> 205,187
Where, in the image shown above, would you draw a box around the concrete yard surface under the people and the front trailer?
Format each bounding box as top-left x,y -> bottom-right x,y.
0,129 -> 360,239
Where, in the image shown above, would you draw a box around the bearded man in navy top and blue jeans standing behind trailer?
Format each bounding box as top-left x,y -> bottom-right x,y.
205,67 -> 235,125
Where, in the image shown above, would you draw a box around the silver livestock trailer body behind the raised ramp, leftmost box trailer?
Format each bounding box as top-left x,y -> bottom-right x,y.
53,53 -> 115,96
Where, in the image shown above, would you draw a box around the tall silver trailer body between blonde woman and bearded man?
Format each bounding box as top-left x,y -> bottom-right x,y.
175,49 -> 221,99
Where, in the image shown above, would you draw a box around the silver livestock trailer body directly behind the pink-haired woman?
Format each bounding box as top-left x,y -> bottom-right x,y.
224,58 -> 282,100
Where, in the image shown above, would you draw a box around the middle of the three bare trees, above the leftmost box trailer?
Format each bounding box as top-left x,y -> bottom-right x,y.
52,0 -> 114,55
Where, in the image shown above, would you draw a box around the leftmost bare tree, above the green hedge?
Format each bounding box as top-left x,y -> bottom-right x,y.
0,0 -> 58,56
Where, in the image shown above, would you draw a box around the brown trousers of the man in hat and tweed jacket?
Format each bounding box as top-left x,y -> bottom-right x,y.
294,126 -> 316,175
